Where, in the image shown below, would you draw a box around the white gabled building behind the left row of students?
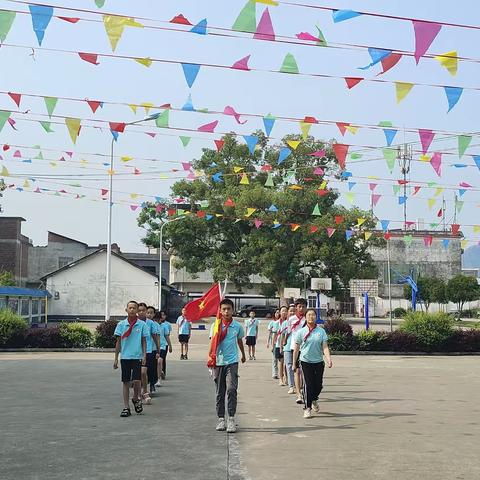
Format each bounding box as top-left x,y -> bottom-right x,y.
42,249 -> 158,320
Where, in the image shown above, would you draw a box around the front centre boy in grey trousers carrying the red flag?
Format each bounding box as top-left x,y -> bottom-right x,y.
213,298 -> 246,433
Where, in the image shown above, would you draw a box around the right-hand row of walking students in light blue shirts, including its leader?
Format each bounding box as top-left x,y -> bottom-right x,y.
267,298 -> 332,418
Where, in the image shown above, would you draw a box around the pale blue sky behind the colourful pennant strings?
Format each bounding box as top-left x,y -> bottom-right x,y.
0,0 -> 480,251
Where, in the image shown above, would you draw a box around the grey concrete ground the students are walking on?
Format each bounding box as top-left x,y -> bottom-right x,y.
0,329 -> 480,480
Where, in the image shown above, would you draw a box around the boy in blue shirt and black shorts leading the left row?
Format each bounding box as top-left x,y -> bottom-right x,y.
113,300 -> 148,417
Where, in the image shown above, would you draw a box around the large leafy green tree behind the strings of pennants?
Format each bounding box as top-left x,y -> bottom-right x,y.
138,131 -> 382,296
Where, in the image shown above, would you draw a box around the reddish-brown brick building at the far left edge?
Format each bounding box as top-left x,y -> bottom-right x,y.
0,217 -> 30,287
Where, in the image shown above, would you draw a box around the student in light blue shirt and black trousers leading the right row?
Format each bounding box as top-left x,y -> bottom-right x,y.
293,308 -> 332,418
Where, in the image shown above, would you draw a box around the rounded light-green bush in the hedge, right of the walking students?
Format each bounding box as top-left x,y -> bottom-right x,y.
400,312 -> 454,351
